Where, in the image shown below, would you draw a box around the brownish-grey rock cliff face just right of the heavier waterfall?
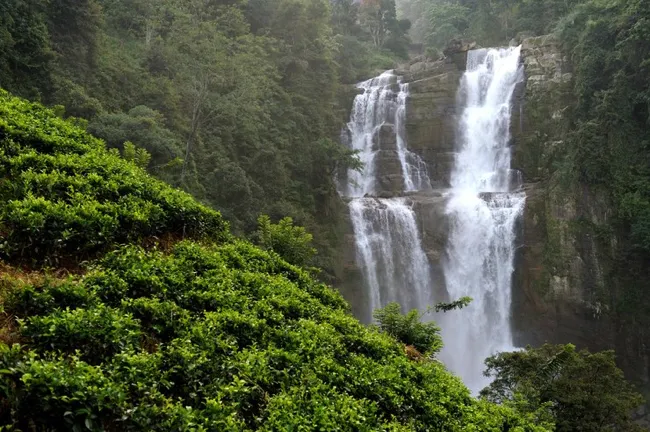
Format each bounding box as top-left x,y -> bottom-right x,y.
512,36 -> 614,349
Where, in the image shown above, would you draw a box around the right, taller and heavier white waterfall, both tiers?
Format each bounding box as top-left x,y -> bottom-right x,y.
440,47 -> 525,393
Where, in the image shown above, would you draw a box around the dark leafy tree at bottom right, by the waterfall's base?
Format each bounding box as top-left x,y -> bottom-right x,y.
481,344 -> 643,432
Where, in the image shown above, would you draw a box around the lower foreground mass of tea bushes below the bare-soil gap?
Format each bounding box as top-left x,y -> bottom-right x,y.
0,241 -> 545,431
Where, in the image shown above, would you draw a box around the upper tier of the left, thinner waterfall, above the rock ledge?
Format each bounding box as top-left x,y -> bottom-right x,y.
341,71 -> 431,197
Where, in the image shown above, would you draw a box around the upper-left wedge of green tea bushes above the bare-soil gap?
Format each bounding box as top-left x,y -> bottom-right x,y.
0,91 -> 227,263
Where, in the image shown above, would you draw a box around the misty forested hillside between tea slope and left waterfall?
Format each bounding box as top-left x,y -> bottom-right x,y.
0,0 -> 408,278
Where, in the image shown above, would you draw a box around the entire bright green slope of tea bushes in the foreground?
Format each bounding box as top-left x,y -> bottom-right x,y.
0,93 -> 551,432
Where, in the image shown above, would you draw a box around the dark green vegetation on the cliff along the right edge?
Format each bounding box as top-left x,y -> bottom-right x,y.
559,1 -> 650,344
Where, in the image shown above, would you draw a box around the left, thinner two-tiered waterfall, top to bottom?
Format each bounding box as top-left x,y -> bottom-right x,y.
339,71 -> 431,317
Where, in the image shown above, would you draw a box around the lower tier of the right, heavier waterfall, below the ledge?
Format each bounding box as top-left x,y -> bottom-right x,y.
437,193 -> 526,393
